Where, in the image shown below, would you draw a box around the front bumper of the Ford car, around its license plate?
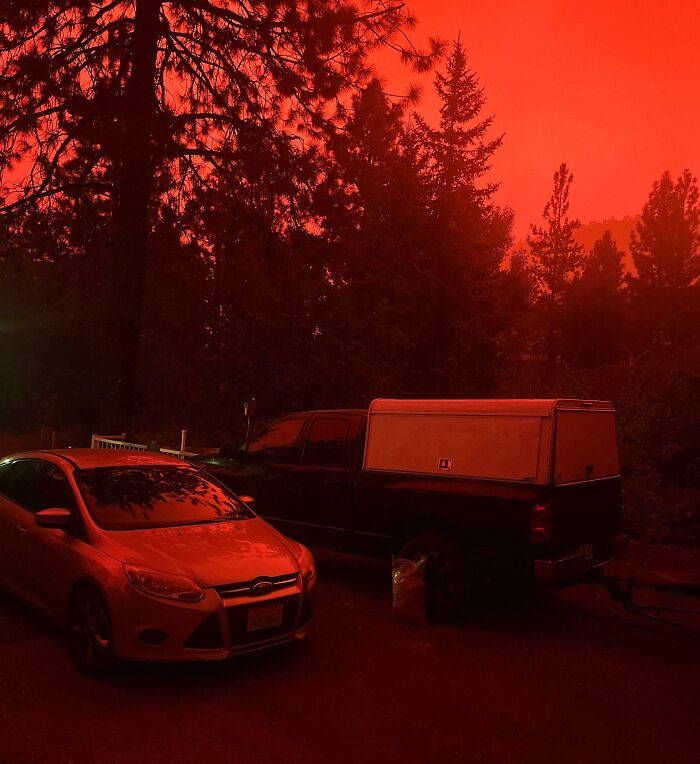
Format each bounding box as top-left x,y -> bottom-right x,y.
110,582 -> 317,662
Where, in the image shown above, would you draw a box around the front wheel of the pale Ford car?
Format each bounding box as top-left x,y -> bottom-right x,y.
67,587 -> 116,678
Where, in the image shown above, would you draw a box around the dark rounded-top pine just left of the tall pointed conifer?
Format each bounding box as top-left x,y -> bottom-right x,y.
315,80 -> 431,405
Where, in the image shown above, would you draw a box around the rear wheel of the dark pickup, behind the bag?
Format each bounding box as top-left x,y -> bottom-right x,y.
399,533 -> 467,623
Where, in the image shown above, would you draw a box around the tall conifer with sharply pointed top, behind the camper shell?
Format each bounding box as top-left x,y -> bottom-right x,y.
407,40 -> 512,397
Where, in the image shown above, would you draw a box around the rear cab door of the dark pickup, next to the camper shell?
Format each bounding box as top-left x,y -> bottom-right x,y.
280,412 -> 365,549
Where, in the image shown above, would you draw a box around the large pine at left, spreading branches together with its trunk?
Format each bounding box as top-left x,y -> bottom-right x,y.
0,0 -> 440,418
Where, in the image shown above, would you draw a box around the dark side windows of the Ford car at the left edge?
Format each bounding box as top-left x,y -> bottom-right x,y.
0,459 -> 75,512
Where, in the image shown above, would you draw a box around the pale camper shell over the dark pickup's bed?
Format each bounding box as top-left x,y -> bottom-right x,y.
363,398 -> 620,485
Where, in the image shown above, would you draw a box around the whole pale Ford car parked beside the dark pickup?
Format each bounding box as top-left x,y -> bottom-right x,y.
0,449 -> 316,675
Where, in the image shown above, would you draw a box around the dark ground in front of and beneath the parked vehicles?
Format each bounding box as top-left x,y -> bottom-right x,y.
0,545 -> 700,764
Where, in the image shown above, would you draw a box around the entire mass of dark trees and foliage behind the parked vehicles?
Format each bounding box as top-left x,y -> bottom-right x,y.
0,8 -> 700,540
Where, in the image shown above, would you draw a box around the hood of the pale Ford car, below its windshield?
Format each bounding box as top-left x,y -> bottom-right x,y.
98,517 -> 300,586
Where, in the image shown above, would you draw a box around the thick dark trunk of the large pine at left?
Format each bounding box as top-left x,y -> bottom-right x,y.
104,0 -> 161,430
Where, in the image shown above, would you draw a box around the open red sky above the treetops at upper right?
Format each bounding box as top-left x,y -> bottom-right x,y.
379,0 -> 700,237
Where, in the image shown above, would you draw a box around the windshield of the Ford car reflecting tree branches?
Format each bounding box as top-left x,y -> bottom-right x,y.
76,464 -> 255,531
